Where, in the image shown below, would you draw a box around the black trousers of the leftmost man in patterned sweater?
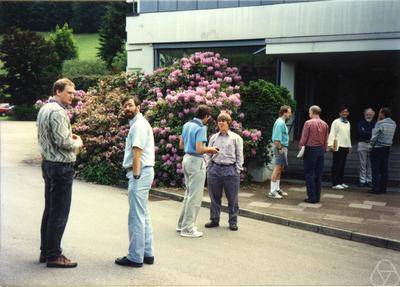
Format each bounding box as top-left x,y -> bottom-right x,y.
40,160 -> 74,259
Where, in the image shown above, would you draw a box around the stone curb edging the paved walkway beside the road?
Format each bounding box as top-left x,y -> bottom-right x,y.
150,189 -> 400,251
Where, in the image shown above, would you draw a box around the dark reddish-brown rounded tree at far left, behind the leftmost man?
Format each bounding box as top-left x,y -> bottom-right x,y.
0,28 -> 61,105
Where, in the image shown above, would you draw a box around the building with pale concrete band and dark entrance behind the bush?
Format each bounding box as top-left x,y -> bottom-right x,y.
126,0 -> 400,182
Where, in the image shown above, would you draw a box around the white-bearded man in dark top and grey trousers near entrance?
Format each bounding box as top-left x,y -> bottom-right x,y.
357,108 -> 376,187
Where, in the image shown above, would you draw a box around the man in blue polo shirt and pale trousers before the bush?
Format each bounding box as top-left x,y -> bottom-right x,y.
176,105 -> 218,237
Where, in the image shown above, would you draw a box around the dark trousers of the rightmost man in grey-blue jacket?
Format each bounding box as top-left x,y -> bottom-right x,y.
371,147 -> 390,193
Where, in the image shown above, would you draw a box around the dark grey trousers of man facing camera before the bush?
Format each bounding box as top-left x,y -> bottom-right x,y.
207,163 -> 240,223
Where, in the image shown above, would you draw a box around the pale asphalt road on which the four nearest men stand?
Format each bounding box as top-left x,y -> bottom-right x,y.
0,122 -> 400,286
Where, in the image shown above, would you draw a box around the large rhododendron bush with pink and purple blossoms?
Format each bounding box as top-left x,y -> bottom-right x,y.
40,52 -> 261,187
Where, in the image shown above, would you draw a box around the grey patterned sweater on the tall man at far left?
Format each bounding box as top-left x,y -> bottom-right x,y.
36,102 -> 79,163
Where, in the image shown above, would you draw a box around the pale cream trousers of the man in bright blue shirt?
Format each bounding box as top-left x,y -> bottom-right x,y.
178,154 -> 206,232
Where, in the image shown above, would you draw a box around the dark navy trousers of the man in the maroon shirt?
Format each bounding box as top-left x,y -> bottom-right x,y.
303,146 -> 325,202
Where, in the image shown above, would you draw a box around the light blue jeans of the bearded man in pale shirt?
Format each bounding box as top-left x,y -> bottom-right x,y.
126,167 -> 154,263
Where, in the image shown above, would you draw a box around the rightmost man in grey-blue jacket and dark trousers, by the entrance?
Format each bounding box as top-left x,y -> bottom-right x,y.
369,107 -> 396,194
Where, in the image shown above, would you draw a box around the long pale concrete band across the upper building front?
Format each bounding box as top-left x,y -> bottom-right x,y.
127,0 -> 400,44
